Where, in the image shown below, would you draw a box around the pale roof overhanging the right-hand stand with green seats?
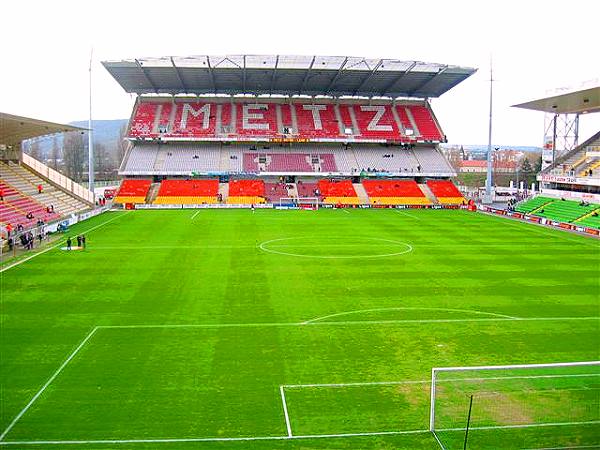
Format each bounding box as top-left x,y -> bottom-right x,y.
513,83 -> 600,114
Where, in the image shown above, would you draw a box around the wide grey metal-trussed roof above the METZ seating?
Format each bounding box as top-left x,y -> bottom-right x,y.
102,55 -> 476,98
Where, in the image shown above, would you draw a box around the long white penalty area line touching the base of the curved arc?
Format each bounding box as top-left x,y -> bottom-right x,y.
97,316 -> 600,328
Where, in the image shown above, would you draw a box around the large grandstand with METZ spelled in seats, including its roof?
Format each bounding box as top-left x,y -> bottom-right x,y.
103,55 -> 475,206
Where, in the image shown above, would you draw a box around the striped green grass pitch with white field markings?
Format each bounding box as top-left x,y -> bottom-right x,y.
0,209 -> 600,450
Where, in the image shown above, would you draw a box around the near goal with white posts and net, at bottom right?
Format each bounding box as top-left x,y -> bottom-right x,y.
429,361 -> 600,450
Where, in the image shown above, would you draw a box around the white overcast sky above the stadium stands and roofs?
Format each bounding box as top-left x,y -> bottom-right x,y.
0,0 -> 600,146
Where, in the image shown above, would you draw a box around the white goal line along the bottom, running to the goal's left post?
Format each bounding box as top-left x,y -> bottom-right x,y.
0,430 -> 430,446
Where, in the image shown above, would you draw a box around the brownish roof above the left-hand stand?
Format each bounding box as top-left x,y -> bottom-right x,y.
0,112 -> 87,144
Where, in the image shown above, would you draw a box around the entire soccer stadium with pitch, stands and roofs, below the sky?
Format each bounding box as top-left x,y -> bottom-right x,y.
0,51 -> 600,450
